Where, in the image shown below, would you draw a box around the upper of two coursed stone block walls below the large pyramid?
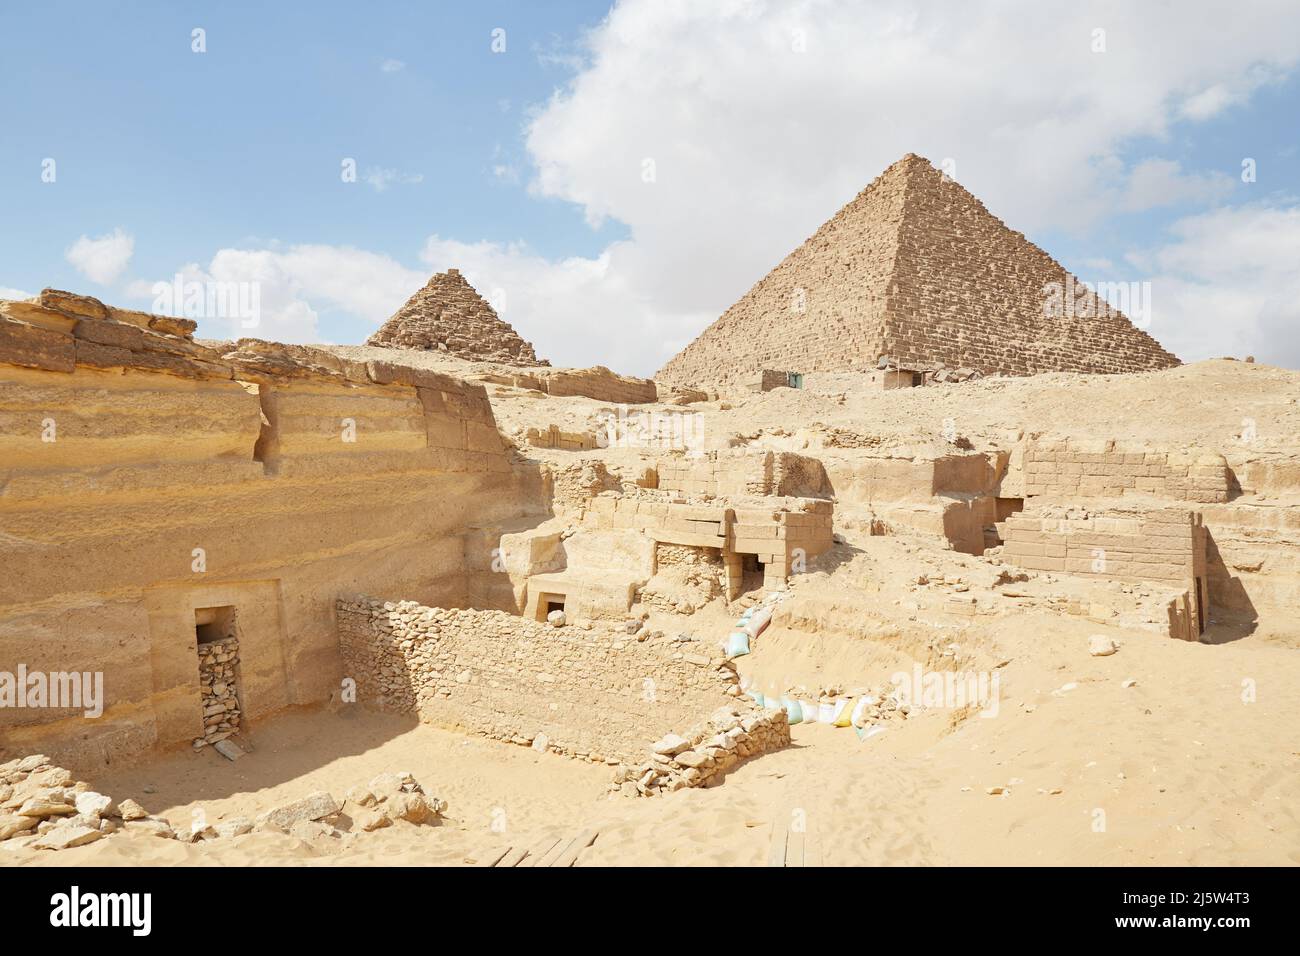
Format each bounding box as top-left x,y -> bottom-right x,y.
1022,441 -> 1231,502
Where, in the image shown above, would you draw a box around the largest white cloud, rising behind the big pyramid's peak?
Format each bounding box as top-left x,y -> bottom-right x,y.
509,0 -> 1300,373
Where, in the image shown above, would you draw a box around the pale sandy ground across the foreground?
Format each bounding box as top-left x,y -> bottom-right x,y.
0,567 -> 1300,865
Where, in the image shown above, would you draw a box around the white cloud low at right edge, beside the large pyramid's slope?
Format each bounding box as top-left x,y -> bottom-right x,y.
1131,206 -> 1300,368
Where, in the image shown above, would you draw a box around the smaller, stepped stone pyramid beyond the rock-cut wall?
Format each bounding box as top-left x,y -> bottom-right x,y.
365,269 -> 549,365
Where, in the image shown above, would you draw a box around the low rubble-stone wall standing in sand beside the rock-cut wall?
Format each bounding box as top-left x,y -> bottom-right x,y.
337,598 -> 740,765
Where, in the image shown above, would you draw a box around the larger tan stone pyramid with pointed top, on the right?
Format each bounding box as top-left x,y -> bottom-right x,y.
655,153 -> 1179,384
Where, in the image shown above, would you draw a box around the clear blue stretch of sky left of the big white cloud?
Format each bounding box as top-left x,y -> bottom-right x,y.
0,3 -> 618,341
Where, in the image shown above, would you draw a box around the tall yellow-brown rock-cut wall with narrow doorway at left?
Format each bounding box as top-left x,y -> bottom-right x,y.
0,291 -> 543,765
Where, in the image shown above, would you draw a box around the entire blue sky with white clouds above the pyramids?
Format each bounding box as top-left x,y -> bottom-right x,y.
0,0 -> 1300,373
